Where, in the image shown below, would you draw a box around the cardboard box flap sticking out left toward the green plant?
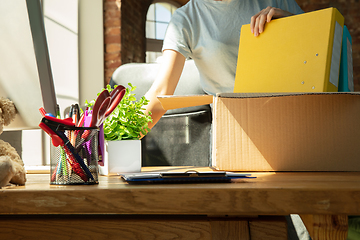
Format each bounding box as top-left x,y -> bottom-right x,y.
157,95 -> 214,110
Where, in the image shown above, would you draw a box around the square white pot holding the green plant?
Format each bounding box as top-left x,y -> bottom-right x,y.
99,140 -> 141,175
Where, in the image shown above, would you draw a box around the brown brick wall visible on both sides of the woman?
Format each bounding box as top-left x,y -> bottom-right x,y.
104,0 -> 360,91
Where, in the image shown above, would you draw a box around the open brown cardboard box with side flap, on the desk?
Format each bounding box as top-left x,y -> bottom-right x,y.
159,93 -> 360,171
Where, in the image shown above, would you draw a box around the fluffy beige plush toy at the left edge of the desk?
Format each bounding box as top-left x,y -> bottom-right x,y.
0,97 -> 26,188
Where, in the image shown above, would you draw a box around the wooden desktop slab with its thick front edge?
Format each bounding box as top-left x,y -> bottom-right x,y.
0,167 -> 360,216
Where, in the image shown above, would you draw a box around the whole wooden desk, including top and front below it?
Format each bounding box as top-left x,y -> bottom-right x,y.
0,169 -> 360,240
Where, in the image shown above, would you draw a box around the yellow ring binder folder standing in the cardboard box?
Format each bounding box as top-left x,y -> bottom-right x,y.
234,8 -> 344,92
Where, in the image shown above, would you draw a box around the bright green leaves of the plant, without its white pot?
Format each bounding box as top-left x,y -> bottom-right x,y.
86,83 -> 152,141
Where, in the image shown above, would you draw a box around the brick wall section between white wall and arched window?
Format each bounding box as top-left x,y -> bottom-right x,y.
104,0 -> 152,84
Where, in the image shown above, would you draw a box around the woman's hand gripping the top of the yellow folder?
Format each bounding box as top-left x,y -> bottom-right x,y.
250,7 -> 293,37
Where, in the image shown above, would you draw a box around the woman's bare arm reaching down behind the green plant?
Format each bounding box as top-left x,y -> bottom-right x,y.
145,50 -> 185,131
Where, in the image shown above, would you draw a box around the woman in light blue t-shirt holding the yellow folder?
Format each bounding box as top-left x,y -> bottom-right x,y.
145,0 -> 303,127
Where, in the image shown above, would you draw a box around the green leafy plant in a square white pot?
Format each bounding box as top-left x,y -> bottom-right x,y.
86,83 -> 152,175
